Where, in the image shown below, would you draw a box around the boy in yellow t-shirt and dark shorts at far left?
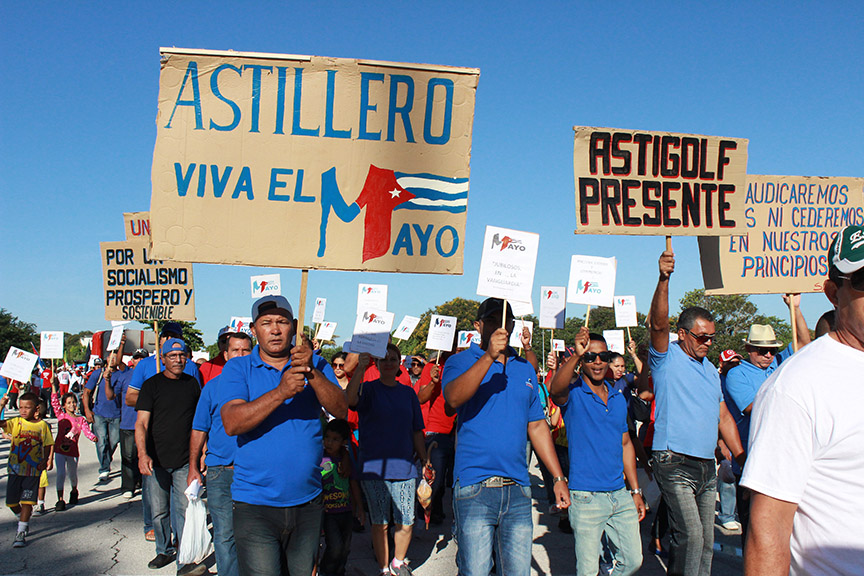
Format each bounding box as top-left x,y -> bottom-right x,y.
0,392 -> 54,548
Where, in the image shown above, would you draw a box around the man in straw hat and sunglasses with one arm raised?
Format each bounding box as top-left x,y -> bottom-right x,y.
725,306 -> 810,542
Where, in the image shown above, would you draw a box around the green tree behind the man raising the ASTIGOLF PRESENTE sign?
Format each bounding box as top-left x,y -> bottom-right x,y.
670,288 -> 792,364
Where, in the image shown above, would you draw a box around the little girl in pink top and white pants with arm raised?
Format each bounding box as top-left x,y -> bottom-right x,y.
51,383 -> 96,512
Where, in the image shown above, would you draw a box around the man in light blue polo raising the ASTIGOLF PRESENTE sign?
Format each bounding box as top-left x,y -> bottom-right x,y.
649,250 -> 744,576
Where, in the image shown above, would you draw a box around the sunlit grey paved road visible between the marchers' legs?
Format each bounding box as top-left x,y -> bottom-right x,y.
0,412 -> 742,576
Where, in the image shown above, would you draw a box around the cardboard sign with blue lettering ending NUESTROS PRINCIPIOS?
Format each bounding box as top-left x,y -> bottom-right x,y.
699,174 -> 864,294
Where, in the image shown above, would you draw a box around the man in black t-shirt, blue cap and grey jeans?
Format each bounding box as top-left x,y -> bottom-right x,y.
135,338 -> 207,576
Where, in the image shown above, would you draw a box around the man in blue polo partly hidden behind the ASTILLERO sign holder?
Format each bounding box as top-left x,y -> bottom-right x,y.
187,332 -> 252,576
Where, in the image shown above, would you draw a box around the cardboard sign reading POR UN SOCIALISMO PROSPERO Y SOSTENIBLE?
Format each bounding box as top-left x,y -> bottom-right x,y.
99,240 -> 195,320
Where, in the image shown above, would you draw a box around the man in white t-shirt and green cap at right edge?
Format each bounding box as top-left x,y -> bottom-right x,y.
741,226 -> 864,576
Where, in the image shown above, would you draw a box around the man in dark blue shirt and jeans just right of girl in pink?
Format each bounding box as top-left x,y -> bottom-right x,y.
83,356 -> 126,482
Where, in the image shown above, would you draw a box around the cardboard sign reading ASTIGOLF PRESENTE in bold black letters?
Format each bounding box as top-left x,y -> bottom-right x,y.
573,126 -> 748,236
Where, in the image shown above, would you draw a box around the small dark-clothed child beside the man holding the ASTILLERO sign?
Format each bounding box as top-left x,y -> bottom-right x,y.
318,419 -> 365,576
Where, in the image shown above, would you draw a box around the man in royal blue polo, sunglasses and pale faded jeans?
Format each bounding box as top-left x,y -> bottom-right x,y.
549,326 -> 645,576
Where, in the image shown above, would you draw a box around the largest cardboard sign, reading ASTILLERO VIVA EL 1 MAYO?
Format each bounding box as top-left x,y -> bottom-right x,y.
150,48 -> 480,274
